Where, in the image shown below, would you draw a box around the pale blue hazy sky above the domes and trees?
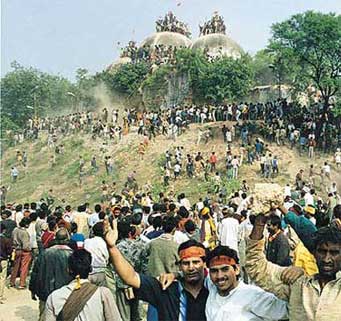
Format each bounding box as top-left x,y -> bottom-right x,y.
1,0 -> 341,80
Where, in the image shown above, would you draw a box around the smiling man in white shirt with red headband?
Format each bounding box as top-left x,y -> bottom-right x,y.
206,246 -> 287,321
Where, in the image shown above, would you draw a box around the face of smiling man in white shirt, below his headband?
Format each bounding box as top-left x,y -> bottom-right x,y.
210,264 -> 240,296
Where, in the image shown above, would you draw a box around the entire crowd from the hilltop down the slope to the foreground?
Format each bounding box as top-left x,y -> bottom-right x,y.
0,90 -> 341,321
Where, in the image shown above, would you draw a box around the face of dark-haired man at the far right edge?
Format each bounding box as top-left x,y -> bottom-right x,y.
315,242 -> 341,278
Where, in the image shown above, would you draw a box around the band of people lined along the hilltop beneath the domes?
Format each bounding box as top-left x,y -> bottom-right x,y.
13,99 -> 341,152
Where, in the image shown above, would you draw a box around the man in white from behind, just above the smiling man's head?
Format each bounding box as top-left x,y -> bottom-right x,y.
218,208 -> 239,252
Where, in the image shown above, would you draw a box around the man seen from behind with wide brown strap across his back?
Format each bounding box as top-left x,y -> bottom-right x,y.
46,249 -> 121,321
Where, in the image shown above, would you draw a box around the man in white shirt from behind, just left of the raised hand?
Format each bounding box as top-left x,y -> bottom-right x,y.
84,222 -> 109,285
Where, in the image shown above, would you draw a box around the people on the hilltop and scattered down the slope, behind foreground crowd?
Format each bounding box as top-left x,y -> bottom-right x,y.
5,95 -> 341,194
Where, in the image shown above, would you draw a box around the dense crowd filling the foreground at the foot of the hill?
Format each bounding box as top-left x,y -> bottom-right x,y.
0,159 -> 341,321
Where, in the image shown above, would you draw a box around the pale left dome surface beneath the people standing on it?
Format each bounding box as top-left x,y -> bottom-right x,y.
140,31 -> 192,49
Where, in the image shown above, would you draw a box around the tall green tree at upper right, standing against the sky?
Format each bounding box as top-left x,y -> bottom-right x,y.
269,11 -> 341,109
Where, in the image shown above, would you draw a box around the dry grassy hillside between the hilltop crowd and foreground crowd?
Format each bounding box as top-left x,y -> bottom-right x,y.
1,123 -> 340,205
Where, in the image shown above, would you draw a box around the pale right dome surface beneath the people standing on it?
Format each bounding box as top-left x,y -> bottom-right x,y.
191,33 -> 244,59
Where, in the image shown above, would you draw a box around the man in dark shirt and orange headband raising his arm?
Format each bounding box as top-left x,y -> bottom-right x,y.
105,221 -> 208,321
